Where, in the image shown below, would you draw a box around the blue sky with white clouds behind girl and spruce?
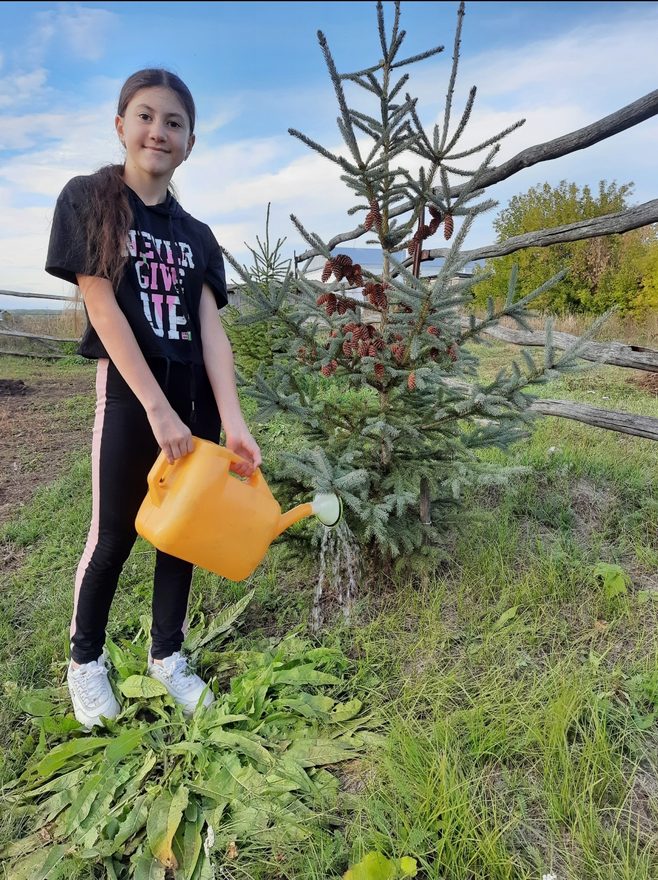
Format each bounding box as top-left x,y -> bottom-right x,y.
0,0 -> 658,307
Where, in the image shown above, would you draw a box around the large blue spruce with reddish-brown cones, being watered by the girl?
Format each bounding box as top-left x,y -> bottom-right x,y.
227,2 -> 592,574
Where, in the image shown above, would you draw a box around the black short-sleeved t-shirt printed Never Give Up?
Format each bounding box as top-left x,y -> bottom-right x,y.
46,175 -> 228,363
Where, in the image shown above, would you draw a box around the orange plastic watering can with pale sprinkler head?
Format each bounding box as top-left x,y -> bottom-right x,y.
135,437 -> 341,581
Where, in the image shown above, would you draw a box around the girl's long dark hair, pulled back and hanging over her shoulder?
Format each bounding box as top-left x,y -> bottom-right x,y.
84,67 -> 196,289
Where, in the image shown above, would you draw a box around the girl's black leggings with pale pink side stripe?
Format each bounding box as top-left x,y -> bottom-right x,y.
71,359 -> 220,663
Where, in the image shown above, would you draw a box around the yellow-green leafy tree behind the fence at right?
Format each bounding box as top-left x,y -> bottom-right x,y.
476,180 -> 658,314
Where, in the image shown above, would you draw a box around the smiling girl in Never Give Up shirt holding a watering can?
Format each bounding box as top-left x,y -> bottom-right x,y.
46,69 -> 261,728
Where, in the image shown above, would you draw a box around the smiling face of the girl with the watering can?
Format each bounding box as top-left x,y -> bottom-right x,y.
115,86 -> 194,183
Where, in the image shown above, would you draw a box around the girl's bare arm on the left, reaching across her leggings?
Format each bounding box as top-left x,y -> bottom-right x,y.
77,275 -> 193,464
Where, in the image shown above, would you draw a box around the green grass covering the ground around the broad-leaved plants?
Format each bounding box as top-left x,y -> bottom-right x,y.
0,332 -> 658,880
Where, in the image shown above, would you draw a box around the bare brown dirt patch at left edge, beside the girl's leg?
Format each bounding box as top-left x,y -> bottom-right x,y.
0,367 -> 95,525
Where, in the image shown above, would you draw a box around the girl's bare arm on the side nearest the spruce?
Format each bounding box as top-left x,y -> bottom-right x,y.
199,284 -> 261,477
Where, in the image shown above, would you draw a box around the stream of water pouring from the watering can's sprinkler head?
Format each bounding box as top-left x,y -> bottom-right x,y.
311,519 -> 359,632
